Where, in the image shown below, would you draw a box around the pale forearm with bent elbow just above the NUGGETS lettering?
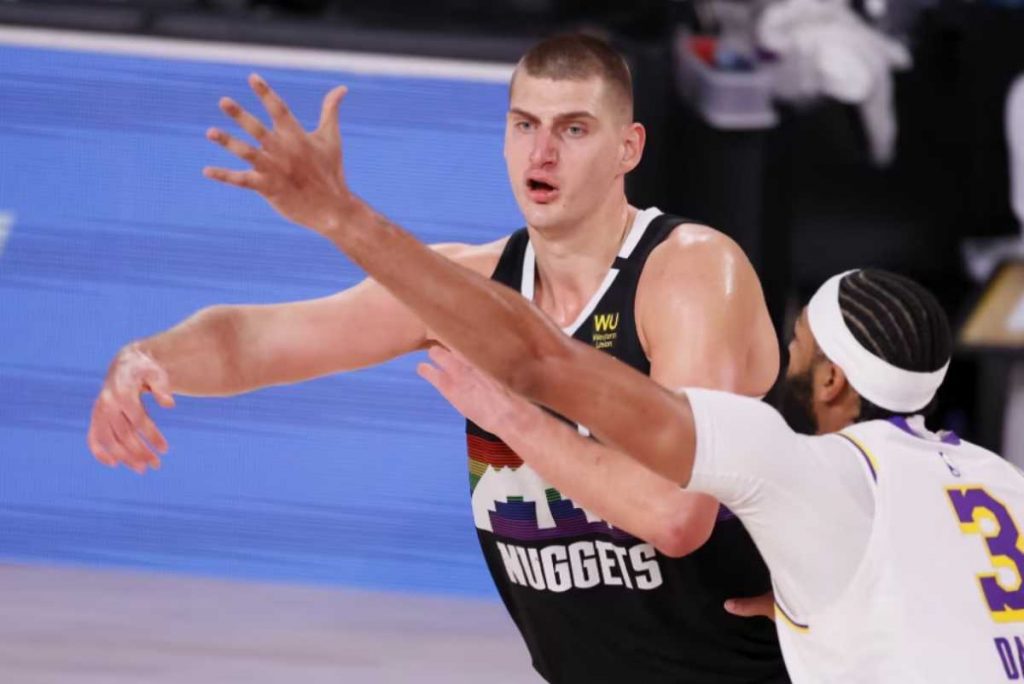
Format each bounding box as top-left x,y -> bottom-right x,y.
499,405 -> 718,556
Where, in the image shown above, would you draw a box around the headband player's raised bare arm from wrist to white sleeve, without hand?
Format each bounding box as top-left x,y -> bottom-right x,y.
322,200 -> 694,483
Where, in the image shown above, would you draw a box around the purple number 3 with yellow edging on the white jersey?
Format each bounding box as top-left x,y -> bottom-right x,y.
946,487 -> 1024,623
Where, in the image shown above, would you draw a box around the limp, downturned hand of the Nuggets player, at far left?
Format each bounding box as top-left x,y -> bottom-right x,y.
86,345 -> 174,474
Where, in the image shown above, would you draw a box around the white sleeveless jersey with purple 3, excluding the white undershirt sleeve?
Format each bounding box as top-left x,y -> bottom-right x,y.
777,421 -> 1024,684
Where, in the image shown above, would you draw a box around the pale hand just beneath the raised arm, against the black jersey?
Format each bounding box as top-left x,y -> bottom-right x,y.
416,346 -> 538,434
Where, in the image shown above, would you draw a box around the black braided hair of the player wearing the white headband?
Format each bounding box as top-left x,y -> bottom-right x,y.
839,268 -> 952,421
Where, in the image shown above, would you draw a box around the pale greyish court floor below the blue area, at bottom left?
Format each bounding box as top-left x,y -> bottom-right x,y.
0,564 -> 541,684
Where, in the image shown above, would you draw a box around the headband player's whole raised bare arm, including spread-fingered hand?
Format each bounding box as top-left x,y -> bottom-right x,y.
205,76 -> 694,483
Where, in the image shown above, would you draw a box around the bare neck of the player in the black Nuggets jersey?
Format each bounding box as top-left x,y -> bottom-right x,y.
528,195 -> 637,327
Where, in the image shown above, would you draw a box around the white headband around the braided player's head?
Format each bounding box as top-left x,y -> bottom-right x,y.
807,270 -> 949,413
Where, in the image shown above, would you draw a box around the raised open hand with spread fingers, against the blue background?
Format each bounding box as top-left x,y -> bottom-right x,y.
203,74 -> 351,233
